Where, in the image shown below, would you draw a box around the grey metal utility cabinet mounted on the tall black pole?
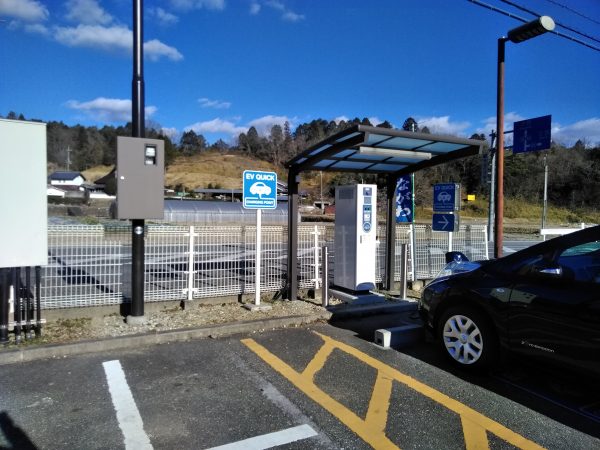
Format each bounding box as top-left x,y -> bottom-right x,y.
117,136 -> 165,219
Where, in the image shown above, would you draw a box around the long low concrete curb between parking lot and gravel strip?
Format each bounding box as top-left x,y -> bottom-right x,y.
0,312 -> 331,366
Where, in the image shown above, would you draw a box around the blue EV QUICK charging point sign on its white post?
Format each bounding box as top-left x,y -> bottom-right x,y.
242,170 -> 277,306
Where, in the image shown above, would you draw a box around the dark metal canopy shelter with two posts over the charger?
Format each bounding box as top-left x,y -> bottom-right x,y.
286,125 -> 484,300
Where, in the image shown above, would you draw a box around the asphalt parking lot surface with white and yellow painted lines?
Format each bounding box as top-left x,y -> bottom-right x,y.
0,313 -> 600,449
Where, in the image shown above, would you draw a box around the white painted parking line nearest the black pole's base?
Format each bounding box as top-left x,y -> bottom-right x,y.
102,360 -> 152,450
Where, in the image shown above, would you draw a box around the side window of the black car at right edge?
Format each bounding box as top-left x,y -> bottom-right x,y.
557,241 -> 600,283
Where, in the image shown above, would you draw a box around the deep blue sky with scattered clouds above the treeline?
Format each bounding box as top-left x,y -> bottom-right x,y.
0,0 -> 600,144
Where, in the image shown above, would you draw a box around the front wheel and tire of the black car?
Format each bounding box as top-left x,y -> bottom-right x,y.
437,305 -> 498,372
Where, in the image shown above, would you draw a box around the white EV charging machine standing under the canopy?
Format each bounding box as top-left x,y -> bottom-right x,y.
334,184 -> 377,293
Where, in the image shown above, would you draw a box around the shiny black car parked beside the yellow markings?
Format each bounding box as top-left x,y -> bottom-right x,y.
419,226 -> 600,377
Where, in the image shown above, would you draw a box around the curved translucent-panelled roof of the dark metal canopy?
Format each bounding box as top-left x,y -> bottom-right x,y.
286,125 -> 484,176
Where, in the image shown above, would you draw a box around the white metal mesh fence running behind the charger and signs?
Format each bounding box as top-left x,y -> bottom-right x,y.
36,224 -> 487,309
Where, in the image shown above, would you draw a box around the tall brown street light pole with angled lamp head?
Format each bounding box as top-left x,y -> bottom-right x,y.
494,16 -> 554,258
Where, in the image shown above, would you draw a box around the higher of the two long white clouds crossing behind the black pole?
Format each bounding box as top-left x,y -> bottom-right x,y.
54,25 -> 183,61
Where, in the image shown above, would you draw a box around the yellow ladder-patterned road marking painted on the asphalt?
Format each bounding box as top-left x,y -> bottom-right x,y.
242,333 -> 543,450
